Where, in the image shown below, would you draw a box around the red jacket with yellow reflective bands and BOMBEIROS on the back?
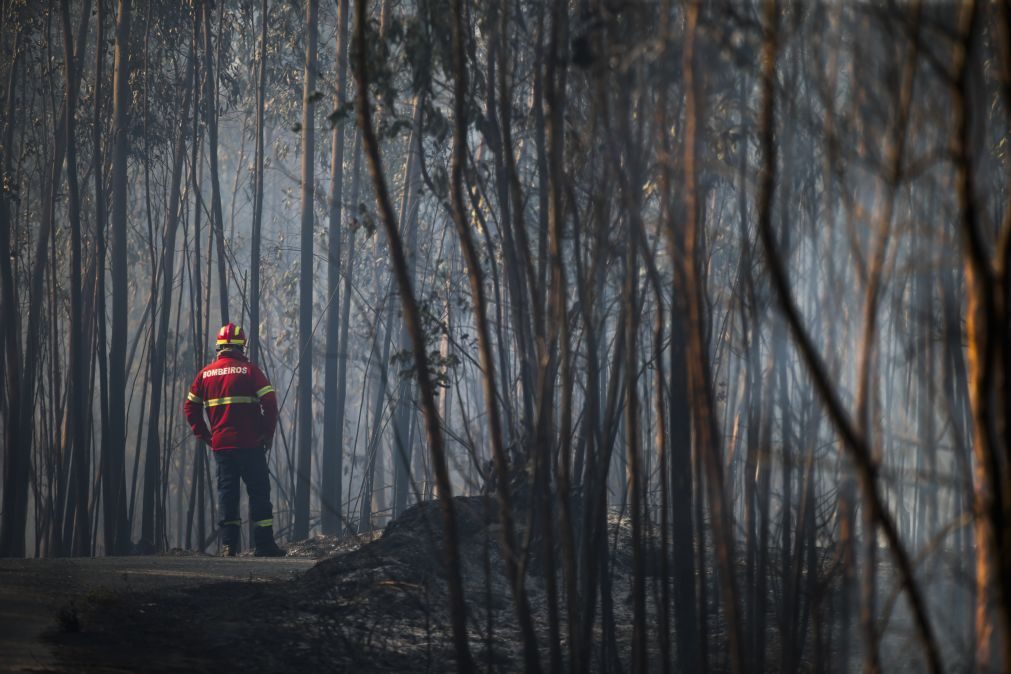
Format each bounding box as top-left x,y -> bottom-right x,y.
183,350 -> 277,451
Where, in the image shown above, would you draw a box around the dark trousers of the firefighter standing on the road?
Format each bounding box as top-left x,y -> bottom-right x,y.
211,448 -> 274,548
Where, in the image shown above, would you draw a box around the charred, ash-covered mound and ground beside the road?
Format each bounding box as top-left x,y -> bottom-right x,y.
51,497 -> 651,672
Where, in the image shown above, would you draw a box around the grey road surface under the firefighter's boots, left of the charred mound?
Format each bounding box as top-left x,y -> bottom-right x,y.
0,556 -> 315,672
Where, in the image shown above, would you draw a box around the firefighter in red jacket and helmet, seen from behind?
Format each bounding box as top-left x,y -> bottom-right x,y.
184,323 -> 285,557
